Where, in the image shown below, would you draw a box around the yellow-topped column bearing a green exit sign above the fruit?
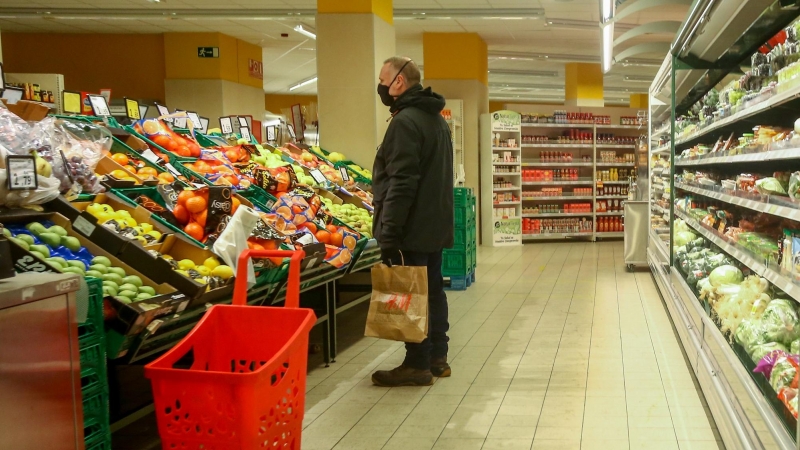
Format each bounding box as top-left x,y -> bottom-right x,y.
164,33 -> 264,123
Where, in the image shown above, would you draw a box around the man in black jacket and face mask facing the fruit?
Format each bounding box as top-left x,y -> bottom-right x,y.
372,56 -> 453,386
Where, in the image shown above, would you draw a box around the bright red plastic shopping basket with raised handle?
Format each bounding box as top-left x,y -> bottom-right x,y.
145,250 -> 316,450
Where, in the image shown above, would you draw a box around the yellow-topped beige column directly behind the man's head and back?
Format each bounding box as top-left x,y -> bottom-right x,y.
422,33 -> 489,236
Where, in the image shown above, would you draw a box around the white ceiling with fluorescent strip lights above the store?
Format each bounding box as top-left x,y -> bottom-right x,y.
0,0 -> 687,100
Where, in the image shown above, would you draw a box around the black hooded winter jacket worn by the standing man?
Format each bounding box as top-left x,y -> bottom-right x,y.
372,85 -> 453,253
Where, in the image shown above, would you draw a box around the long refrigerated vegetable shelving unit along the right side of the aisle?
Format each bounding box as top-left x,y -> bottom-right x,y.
647,0 -> 800,450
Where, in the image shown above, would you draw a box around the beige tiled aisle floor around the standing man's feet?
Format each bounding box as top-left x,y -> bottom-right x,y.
303,242 -> 723,450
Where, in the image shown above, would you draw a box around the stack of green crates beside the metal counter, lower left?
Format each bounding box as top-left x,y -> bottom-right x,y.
78,277 -> 111,450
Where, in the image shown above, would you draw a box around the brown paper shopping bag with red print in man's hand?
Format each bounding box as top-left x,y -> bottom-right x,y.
364,264 -> 428,343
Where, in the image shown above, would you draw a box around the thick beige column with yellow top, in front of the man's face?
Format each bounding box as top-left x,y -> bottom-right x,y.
316,0 -> 395,168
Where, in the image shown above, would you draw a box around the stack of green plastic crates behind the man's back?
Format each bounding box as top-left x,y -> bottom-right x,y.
442,187 -> 478,291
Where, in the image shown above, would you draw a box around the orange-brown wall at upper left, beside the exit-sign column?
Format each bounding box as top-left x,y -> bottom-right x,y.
2,32 -> 166,102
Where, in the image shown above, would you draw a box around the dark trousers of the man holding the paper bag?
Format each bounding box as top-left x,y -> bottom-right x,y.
392,250 -> 450,370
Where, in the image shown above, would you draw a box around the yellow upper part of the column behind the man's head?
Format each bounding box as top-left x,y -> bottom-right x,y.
422,33 -> 489,86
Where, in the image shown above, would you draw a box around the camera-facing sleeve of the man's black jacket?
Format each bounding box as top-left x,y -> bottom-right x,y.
380,119 -> 422,249
